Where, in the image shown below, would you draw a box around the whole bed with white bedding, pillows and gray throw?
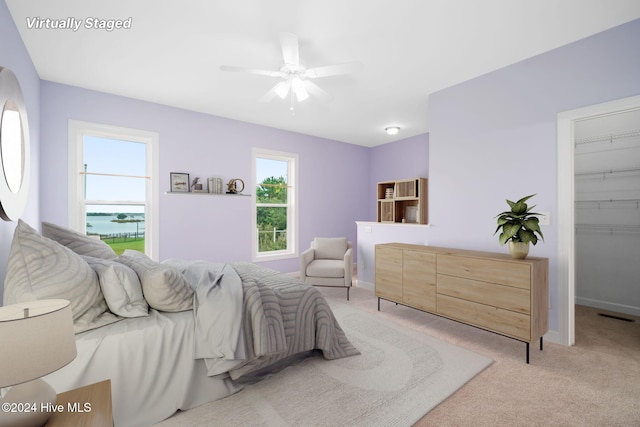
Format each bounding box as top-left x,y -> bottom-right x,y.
4,221 -> 359,426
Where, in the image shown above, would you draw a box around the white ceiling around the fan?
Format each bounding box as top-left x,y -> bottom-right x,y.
6,0 -> 640,146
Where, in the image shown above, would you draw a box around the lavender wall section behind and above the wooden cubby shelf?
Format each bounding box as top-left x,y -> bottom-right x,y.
368,133 -> 429,221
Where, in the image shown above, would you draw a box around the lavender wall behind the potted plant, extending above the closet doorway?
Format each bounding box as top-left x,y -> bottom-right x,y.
429,20 -> 640,330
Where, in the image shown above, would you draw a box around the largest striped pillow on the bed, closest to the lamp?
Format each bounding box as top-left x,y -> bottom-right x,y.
4,220 -> 120,333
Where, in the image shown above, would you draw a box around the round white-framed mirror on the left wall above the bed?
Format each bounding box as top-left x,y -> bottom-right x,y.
0,67 -> 31,221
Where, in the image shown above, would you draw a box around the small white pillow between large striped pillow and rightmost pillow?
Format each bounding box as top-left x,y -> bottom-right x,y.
83,256 -> 149,317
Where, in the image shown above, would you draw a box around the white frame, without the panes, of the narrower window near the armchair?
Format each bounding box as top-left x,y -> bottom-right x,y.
251,147 -> 299,262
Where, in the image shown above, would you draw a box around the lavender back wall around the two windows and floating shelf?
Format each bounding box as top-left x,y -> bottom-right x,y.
41,81 -> 370,271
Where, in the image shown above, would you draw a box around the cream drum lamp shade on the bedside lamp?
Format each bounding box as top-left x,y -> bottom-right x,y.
0,299 -> 77,387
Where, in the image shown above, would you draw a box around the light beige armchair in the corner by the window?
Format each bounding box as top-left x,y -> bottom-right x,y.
300,237 -> 353,301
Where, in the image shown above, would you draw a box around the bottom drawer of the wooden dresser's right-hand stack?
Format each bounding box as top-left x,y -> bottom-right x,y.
436,294 -> 531,341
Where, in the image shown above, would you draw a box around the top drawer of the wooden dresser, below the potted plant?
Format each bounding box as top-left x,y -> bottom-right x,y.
436,254 -> 531,289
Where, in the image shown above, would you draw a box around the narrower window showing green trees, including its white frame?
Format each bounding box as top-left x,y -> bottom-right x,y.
252,148 -> 298,261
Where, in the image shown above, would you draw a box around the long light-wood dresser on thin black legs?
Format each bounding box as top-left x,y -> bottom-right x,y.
375,243 -> 549,363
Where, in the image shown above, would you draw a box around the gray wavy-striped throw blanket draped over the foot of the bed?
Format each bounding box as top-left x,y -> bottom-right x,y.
167,260 -> 360,379
